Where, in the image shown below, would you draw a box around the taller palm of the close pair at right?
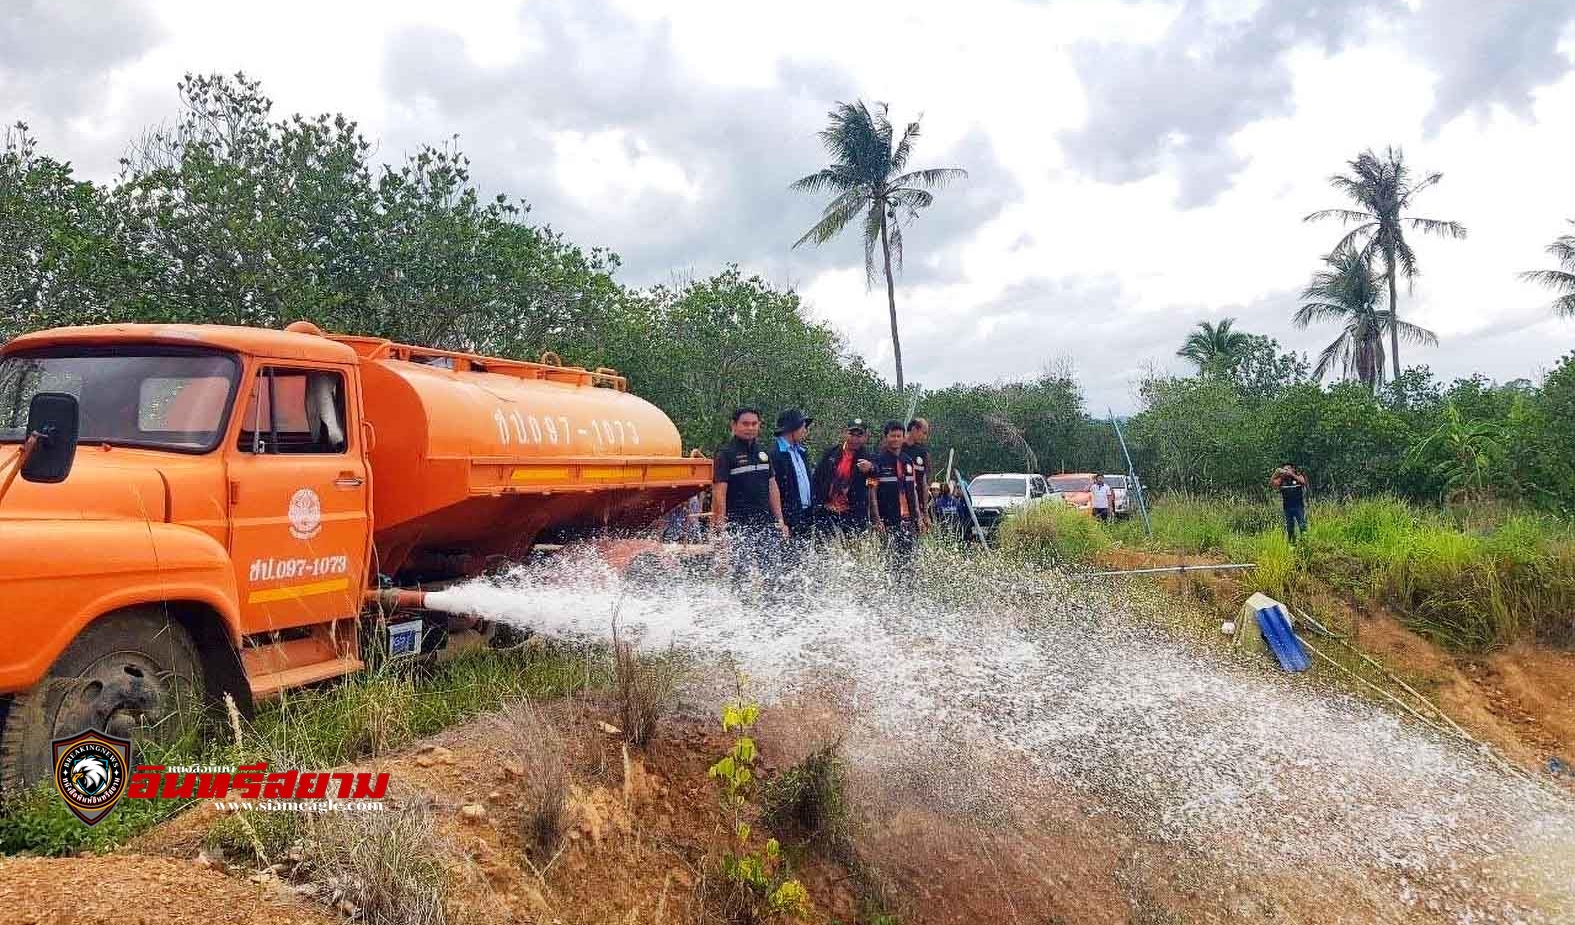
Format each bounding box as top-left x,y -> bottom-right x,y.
1303,148 -> 1466,377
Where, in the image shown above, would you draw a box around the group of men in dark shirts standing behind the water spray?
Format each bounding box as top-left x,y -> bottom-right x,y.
710,408 -> 929,580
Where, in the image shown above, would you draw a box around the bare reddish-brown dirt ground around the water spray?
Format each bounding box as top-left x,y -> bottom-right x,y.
0,550 -> 1575,925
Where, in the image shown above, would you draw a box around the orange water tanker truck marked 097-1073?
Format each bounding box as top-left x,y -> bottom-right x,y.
0,321 -> 710,788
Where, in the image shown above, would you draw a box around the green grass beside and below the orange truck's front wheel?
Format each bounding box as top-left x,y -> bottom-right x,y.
0,646 -> 610,856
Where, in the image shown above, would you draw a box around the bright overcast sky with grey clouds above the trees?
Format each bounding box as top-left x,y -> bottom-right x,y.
0,0 -> 1575,411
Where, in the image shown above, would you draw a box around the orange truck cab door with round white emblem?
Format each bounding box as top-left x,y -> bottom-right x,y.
227,364 -> 370,632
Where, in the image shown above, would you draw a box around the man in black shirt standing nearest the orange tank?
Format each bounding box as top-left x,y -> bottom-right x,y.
710,408 -> 788,585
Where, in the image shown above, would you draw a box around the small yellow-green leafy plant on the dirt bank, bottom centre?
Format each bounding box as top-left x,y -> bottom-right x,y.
706,697 -> 811,922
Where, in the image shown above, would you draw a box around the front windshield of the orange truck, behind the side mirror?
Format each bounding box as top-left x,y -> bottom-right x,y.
0,347 -> 241,452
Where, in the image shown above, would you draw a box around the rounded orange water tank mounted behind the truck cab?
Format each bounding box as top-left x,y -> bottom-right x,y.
344,337 -> 710,575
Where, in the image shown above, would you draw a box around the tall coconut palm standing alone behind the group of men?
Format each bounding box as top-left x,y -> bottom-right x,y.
789,101 -> 969,392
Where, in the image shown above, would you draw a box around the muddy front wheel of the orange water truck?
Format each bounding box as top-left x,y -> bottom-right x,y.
0,608 -> 202,791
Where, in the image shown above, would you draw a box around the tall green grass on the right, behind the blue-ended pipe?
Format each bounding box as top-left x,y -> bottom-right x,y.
1110,495 -> 1575,652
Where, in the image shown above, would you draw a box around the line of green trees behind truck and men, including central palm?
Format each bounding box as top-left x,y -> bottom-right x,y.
0,74 -> 1575,511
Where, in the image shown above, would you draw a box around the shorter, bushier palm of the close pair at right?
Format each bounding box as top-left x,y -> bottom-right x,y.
1292,247 -> 1438,391
